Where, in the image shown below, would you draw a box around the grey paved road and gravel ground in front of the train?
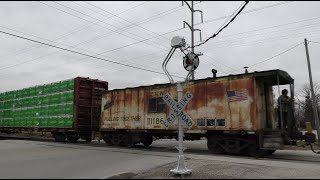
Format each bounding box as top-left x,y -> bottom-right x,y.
0,140 -> 320,179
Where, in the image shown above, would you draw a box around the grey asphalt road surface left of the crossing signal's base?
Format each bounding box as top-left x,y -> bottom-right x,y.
0,140 -> 175,179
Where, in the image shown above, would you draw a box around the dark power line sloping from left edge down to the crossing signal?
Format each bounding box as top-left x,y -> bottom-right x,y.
0,31 -> 184,79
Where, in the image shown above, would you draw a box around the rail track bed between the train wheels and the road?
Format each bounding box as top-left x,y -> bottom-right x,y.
0,135 -> 320,164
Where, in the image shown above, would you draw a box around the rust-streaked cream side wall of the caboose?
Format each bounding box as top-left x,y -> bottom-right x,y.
101,75 -> 257,130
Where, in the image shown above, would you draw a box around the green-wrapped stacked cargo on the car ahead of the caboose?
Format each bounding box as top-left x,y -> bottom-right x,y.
0,79 -> 74,128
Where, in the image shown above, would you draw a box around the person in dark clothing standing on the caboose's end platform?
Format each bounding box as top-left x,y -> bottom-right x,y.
278,89 -> 291,129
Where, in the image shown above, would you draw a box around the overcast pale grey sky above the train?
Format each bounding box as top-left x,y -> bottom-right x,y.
0,1 -> 320,100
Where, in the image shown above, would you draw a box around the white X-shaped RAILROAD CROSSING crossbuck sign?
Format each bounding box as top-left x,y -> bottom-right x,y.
163,91 -> 193,129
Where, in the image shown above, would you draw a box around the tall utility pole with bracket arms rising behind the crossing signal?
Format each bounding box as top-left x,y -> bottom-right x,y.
182,1 -> 203,80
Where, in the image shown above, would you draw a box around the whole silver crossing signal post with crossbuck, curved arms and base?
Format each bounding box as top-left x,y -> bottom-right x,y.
162,36 -> 199,175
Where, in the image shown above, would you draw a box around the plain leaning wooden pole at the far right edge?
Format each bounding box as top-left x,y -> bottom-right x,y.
304,38 -> 320,143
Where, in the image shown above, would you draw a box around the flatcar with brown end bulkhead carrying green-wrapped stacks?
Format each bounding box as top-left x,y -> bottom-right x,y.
0,77 -> 108,142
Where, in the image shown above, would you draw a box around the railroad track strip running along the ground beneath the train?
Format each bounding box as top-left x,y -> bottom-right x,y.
0,135 -> 320,165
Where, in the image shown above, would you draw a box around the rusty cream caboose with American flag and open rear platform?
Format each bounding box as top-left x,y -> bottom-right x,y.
100,70 -> 314,156
